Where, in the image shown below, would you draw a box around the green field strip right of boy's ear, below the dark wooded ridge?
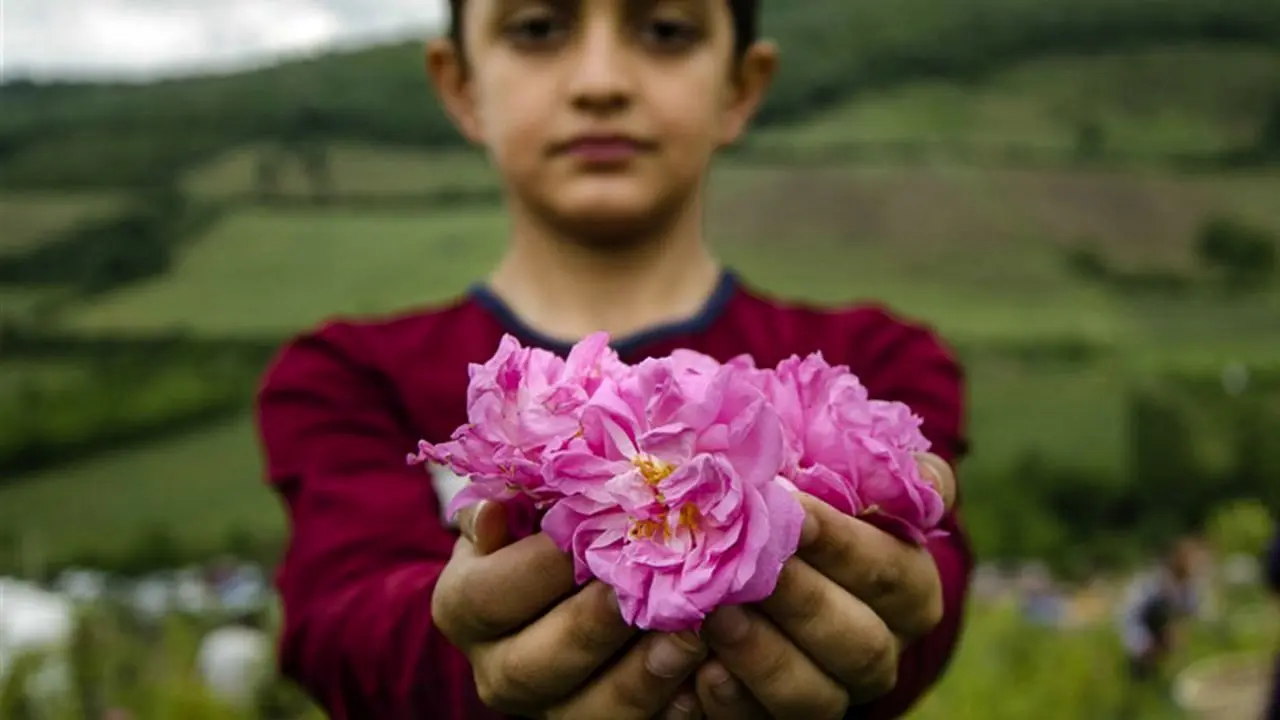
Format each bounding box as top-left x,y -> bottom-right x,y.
751,45 -> 1280,163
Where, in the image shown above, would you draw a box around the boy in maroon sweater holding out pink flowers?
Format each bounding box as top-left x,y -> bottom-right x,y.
259,0 -> 972,720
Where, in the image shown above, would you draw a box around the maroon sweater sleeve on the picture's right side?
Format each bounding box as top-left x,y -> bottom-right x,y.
850,319 -> 974,720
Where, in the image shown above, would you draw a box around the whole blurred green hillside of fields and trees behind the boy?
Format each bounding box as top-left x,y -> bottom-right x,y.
0,0 -> 1280,568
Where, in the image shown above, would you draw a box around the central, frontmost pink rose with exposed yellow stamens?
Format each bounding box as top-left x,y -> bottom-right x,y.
543,355 -> 804,632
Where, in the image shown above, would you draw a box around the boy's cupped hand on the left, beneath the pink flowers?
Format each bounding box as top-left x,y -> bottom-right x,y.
431,502 -> 707,720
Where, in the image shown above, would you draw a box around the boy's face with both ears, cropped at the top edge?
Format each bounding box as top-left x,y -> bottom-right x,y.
428,0 -> 776,238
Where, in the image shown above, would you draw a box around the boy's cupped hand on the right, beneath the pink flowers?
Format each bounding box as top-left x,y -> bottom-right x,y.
696,455 -> 955,720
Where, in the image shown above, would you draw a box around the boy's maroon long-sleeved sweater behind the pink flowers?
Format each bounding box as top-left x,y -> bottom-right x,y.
257,274 -> 973,720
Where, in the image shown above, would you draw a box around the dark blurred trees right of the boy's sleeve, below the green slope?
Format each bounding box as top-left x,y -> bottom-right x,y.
964,374 -> 1280,577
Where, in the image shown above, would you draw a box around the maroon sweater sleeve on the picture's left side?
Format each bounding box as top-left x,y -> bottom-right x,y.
256,325 -> 490,720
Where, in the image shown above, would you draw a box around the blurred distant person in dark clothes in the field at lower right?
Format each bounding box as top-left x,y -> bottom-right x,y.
1120,538 -> 1203,684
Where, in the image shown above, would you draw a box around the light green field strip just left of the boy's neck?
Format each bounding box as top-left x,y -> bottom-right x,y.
58,204 -> 504,337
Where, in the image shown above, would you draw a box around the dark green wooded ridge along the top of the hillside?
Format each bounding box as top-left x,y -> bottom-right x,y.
0,0 -> 1280,187
